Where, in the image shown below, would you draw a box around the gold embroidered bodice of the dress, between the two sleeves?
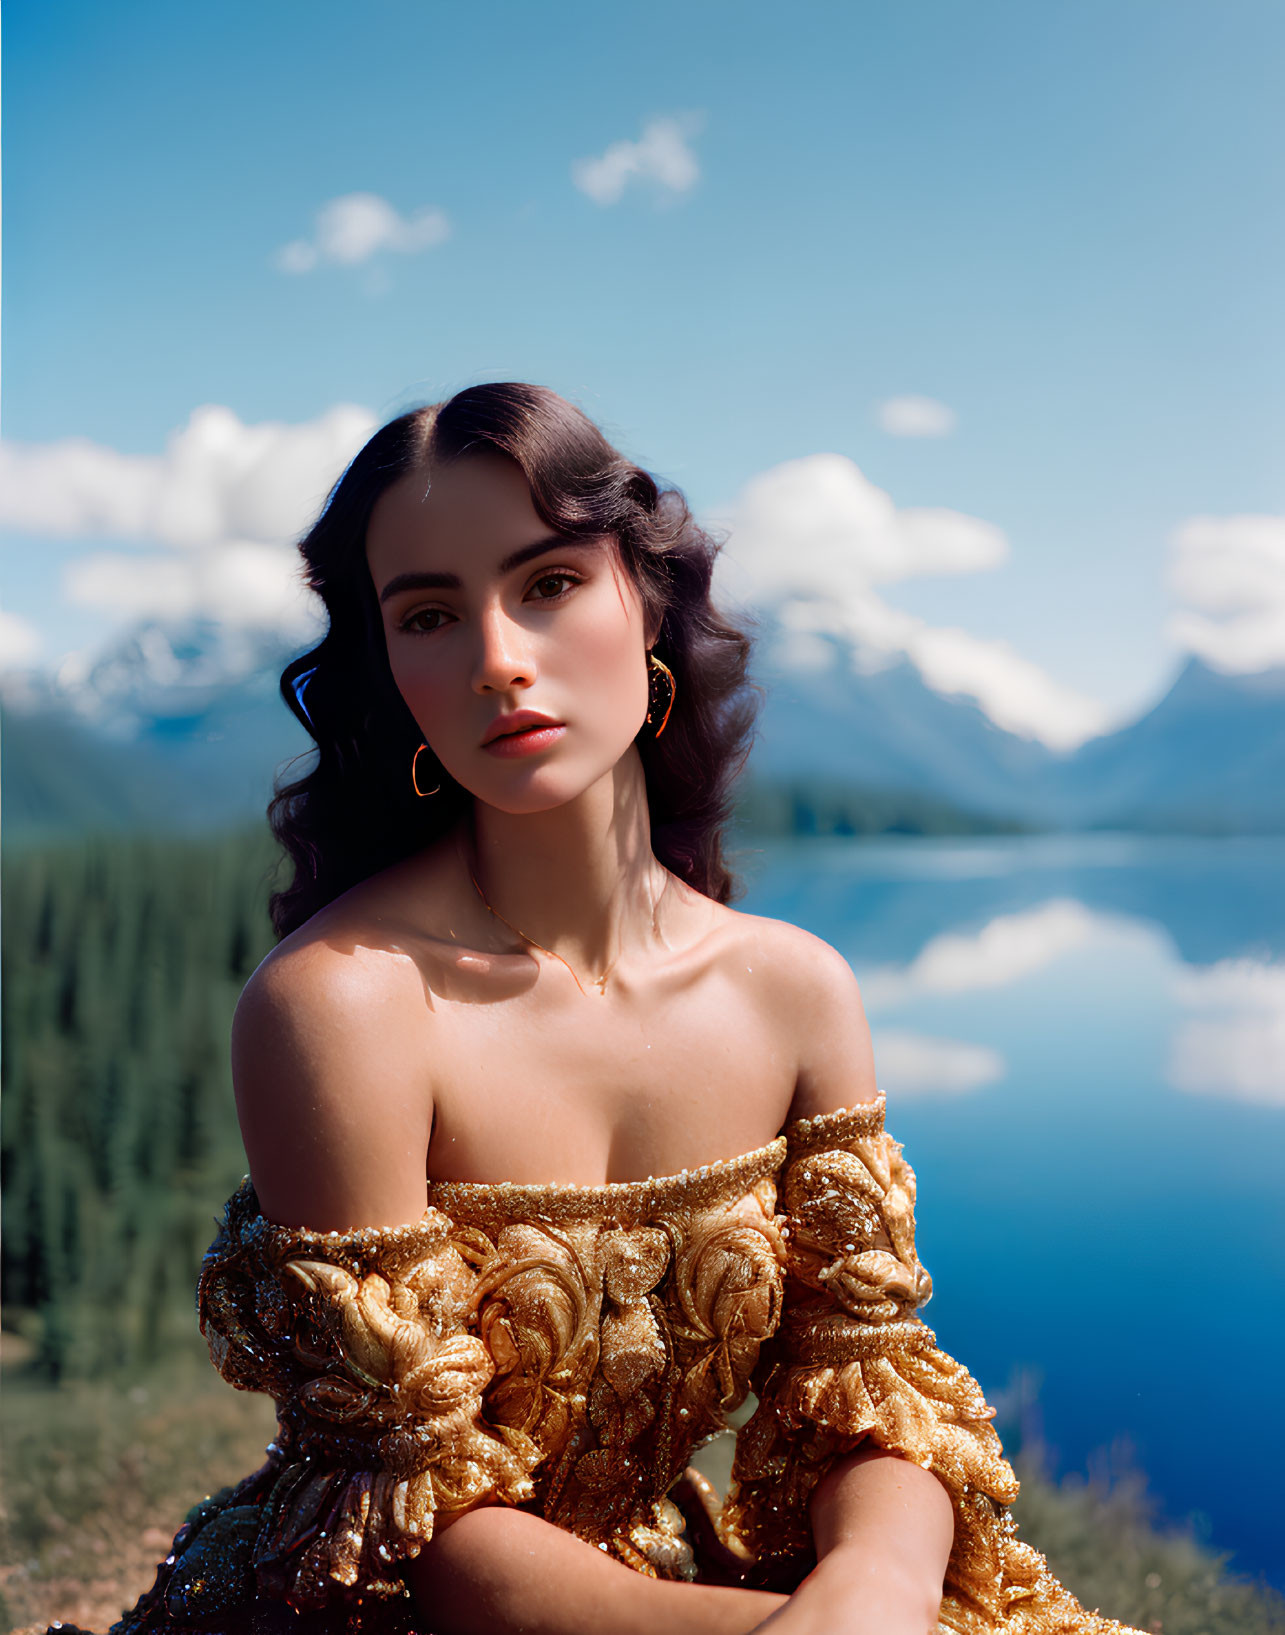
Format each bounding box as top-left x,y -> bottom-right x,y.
430,1140 -> 785,1578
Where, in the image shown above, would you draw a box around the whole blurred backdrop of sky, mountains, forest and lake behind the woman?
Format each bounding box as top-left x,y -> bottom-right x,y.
0,0 -> 1285,1635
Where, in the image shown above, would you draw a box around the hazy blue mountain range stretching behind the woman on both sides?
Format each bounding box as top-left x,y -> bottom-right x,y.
0,616 -> 1285,839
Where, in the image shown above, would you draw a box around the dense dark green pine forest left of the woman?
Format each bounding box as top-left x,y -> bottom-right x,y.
0,834 -> 275,1380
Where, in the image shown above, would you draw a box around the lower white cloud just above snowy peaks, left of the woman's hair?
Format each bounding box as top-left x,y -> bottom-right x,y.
62,540 -> 322,641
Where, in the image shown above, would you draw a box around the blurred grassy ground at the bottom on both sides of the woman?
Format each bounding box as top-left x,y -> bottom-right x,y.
0,1357 -> 1285,1635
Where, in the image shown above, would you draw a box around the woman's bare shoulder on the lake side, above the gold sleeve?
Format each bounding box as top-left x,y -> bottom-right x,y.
706,909 -> 878,1118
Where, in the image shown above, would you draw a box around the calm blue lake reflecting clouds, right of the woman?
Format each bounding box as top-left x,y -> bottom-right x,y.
737,834 -> 1285,1588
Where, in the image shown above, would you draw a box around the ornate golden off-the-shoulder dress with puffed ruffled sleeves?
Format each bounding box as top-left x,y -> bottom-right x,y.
82,1097 -> 1144,1635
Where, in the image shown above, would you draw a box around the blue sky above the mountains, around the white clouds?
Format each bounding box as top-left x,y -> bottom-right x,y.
2,0 -> 1285,742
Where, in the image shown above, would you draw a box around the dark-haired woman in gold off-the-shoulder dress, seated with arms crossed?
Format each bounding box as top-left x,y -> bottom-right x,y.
102,384 -> 1144,1635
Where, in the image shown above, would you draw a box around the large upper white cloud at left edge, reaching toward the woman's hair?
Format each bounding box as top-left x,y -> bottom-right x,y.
0,404 -> 374,548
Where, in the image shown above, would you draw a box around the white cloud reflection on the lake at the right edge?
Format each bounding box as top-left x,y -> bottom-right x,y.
1166,960 -> 1285,1107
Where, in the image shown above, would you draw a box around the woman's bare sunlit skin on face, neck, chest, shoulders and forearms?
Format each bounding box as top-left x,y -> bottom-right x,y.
232,453 -> 953,1635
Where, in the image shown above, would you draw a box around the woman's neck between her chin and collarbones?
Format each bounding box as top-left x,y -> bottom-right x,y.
464,752 -> 669,986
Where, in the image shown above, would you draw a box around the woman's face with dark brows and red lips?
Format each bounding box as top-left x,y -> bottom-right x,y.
366,453 -> 649,813
